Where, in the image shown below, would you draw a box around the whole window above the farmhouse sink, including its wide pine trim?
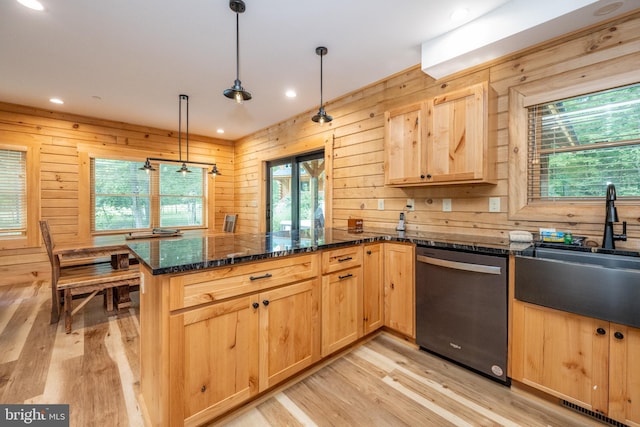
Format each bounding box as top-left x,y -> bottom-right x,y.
507,60 -> 640,224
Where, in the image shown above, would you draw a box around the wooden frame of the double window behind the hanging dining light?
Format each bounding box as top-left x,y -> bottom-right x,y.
78,150 -> 210,238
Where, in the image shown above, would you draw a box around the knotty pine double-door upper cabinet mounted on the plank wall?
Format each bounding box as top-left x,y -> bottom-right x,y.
385,82 -> 496,187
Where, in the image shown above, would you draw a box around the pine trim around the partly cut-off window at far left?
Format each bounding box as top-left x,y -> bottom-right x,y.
0,135 -> 42,250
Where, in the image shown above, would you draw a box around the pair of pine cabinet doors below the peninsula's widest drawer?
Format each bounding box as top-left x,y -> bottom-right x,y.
170,279 -> 320,425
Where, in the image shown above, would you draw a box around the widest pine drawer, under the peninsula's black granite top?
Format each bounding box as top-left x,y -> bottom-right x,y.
169,254 -> 320,310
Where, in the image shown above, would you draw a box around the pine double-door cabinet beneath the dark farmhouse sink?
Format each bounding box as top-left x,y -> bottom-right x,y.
511,301 -> 640,425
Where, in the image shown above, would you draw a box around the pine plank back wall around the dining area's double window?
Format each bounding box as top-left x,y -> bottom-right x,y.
0,103 -> 234,286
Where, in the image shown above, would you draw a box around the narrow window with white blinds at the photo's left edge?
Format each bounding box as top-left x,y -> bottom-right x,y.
0,150 -> 27,237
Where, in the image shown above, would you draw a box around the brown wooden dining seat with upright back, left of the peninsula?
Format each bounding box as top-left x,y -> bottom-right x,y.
40,221 -> 140,333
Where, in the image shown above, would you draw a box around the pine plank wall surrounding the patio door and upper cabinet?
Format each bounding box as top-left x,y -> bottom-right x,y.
235,11 -> 640,252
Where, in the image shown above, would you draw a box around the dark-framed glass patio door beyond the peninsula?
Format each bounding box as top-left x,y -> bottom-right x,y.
267,151 -> 325,236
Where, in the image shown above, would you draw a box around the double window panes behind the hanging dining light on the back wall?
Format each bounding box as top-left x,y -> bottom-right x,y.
91,158 -> 206,232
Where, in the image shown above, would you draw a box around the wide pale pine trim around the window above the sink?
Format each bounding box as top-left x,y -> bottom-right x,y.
508,61 -> 640,224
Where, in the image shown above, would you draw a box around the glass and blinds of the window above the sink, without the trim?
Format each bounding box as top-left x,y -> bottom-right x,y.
527,84 -> 640,202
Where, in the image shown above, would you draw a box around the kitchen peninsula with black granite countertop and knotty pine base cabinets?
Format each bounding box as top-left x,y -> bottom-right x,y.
128,229 -> 512,426
